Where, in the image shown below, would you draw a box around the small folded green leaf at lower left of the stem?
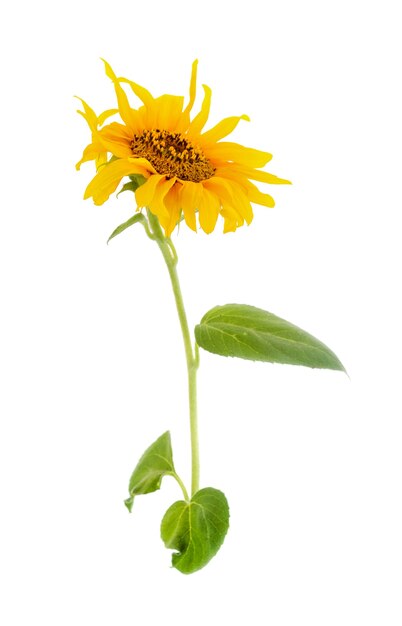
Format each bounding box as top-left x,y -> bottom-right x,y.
124,431 -> 175,511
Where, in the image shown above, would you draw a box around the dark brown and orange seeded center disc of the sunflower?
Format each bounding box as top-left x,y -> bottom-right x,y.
131,129 -> 215,183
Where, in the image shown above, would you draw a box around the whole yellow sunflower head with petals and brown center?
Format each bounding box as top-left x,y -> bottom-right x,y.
76,61 -> 289,237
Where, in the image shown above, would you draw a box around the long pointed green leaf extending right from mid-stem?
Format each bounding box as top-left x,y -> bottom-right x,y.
195,304 -> 345,371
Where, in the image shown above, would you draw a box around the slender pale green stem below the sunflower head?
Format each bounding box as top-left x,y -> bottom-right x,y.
147,210 -> 200,495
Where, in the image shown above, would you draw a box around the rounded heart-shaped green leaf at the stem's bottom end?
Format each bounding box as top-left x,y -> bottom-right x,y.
161,487 -> 229,574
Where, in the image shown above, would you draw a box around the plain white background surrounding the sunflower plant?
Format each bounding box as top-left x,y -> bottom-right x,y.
0,0 -> 402,626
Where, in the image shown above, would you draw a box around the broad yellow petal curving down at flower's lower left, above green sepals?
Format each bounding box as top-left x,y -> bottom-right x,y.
84,159 -> 149,205
